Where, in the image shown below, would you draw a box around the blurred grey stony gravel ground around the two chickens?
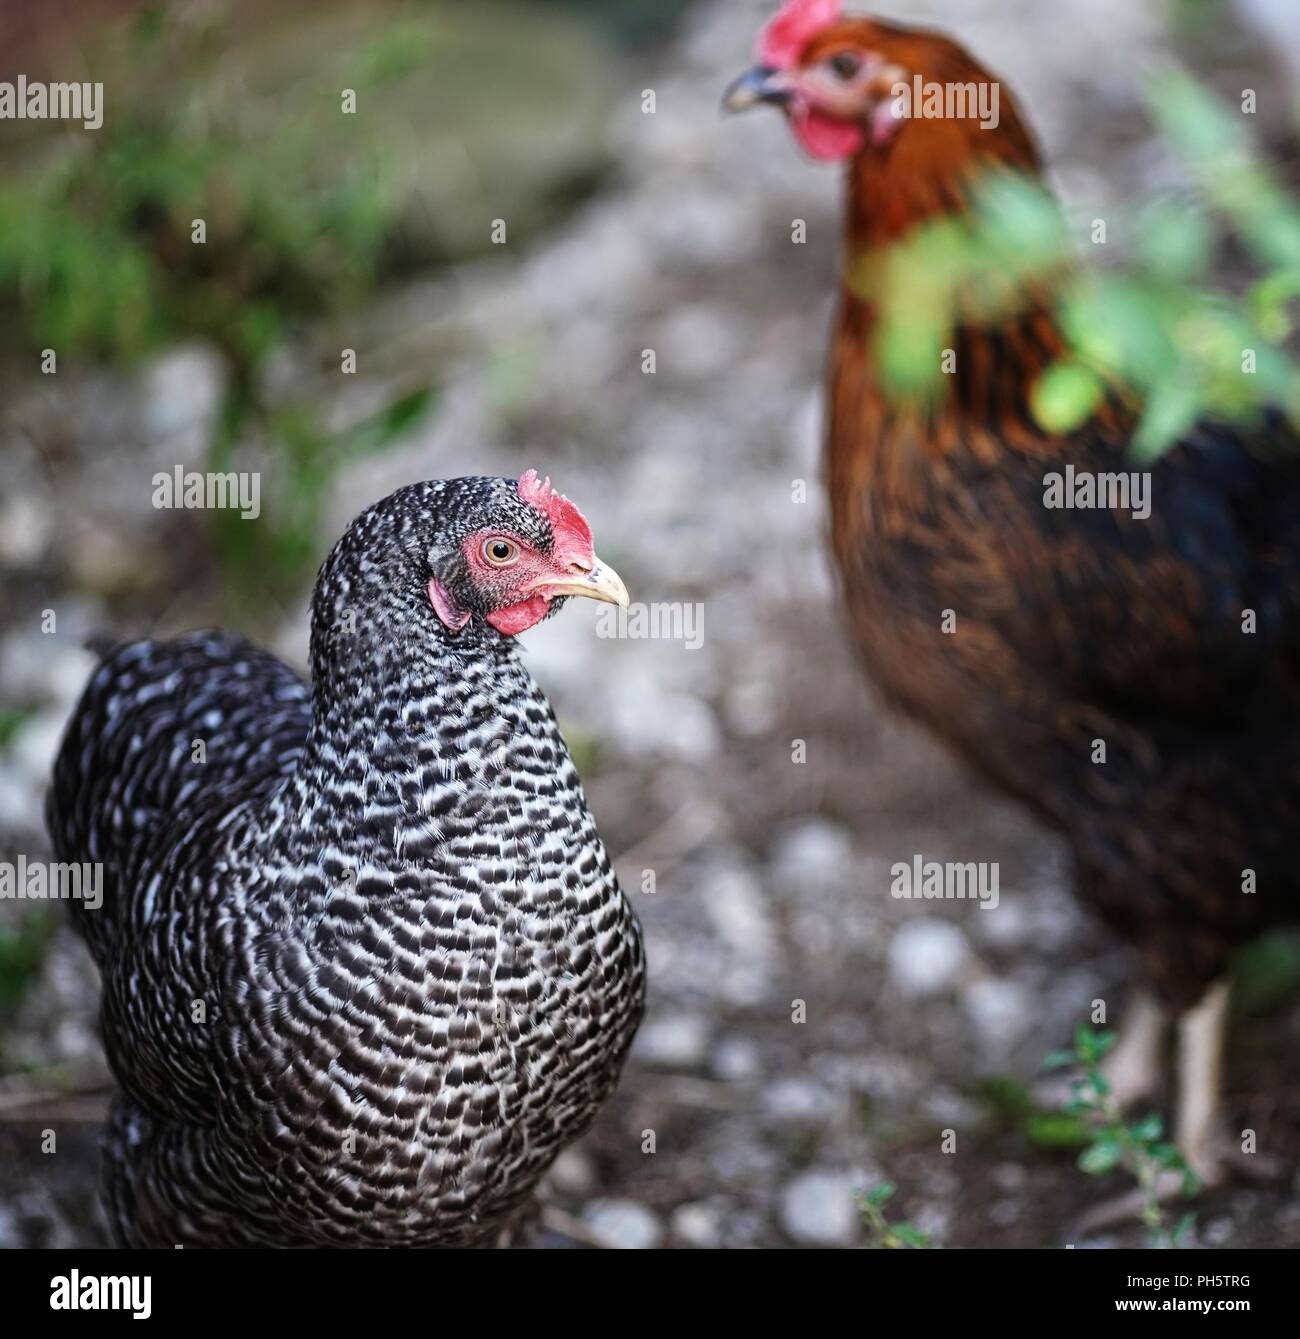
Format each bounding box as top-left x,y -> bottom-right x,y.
0,0 -> 1300,1247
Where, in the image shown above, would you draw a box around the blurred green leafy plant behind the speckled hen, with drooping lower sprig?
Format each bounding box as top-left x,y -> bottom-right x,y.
0,5 -> 447,604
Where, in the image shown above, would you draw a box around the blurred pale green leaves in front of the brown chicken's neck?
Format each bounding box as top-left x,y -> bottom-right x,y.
861,71 -> 1300,459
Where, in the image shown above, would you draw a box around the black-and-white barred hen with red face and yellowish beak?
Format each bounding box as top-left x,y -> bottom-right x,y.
48,471 -> 644,1245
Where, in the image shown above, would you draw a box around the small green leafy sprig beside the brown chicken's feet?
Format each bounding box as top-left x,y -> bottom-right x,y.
1043,1023 -> 1200,1247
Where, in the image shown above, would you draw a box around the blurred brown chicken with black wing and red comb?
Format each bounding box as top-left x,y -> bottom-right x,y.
724,0 -> 1300,1199
